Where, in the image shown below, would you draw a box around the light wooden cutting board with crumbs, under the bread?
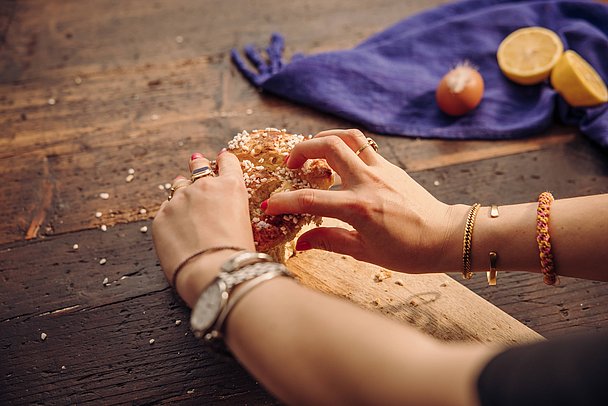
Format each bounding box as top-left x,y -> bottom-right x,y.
287,219 -> 543,344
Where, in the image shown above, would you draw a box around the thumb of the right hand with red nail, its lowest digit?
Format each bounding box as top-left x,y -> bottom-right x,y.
296,227 -> 363,258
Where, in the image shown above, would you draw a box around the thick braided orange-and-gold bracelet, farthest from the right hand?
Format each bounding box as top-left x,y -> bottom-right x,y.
536,192 -> 558,285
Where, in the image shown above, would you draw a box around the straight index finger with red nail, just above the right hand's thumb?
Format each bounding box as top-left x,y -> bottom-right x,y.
262,189 -> 355,222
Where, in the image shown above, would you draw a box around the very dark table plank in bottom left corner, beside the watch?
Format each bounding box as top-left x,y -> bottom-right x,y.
0,289 -> 276,405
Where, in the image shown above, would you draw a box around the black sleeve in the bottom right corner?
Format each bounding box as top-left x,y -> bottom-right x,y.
477,333 -> 608,406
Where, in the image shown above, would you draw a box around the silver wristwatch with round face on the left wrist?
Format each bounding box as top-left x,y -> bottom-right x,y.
190,252 -> 284,339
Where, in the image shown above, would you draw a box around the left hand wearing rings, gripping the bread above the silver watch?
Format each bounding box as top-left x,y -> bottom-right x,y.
152,152 -> 255,306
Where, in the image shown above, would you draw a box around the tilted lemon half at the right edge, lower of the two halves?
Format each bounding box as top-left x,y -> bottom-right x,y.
551,50 -> 608,107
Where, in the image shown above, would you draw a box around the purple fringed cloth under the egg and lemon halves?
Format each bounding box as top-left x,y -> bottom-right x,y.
232,0 -> 608,147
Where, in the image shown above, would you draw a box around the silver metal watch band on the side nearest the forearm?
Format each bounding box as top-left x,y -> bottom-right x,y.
204,262 -> 293,341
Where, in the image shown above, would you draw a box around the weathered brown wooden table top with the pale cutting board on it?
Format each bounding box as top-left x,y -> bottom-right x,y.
0,0 -> 608,404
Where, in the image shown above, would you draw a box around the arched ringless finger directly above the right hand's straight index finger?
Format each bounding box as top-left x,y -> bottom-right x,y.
286,136 -> 366,177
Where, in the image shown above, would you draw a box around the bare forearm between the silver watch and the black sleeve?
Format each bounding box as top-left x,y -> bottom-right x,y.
226,278 -> 493,405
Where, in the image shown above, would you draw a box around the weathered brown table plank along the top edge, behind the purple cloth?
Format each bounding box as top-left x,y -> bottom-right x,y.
0,0 -> 444,83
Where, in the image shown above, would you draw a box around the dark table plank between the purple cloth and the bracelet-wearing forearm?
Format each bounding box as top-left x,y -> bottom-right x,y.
412,138 -> 608,204
